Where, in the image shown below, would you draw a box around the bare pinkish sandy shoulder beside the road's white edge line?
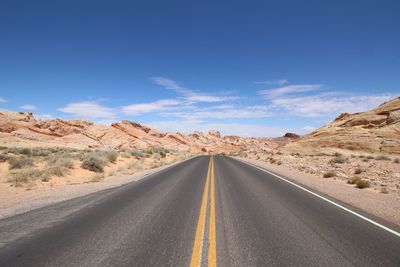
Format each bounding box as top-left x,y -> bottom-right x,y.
237,157 -> 400,225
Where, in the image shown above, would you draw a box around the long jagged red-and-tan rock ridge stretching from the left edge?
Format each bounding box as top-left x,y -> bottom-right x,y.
0,111 -> 276,153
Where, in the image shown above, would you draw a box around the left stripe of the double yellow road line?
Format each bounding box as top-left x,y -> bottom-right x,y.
190,159 -> 211,267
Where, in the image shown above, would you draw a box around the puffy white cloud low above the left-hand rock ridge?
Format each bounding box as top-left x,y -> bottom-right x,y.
58,101 -> 116,119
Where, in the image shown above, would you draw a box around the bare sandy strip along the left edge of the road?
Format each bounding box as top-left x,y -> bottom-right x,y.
0,159 -> 192,219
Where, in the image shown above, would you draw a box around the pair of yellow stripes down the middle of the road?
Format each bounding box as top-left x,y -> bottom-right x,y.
190,157 -> 217,267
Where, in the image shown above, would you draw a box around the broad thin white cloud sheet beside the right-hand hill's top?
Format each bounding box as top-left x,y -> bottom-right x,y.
271,92 -> 392,117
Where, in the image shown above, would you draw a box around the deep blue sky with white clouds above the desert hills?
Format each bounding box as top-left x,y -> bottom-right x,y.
0,0 -> 400,136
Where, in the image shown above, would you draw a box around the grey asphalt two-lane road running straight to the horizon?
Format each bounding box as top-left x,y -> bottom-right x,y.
0,156 -> 400,266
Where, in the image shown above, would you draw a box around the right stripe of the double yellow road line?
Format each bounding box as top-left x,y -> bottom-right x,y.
208,158 -> 217,267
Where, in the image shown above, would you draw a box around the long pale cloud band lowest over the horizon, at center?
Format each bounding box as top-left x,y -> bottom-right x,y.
147,120 -> 286,137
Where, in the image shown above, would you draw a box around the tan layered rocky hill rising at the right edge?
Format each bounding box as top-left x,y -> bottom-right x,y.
286,97 -> 400,154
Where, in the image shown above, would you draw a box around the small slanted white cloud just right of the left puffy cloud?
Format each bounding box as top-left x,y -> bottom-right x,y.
122,99 -> 181,116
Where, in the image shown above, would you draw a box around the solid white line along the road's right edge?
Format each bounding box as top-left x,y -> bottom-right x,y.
233,158 -> 400,237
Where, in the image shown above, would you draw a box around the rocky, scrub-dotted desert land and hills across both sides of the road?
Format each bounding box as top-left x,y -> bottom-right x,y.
0,98 -> 400,197
